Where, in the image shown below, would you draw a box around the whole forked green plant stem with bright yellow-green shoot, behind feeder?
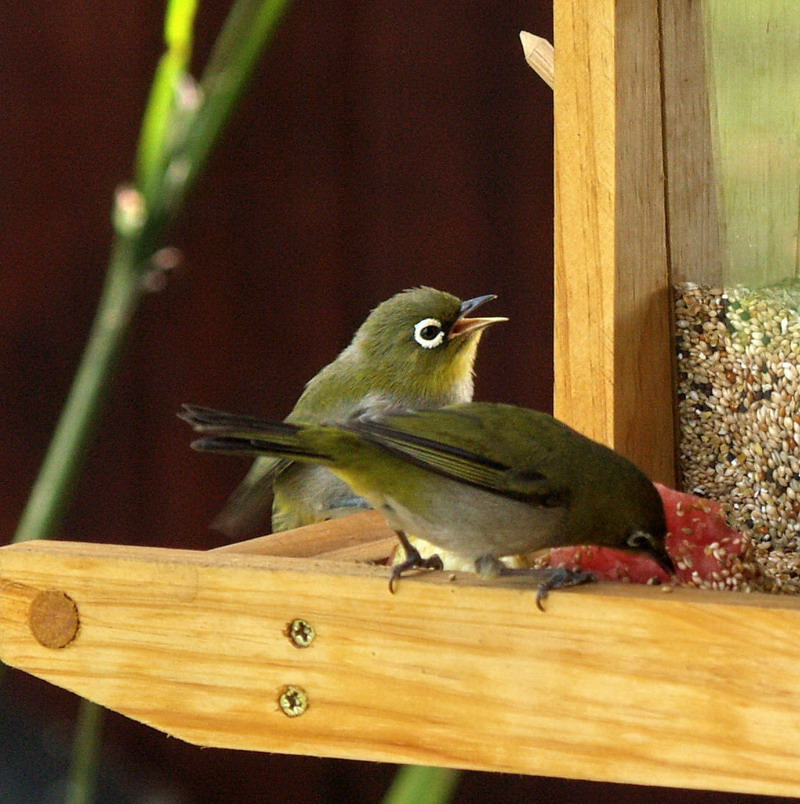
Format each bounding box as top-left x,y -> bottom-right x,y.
10,0 -> 289,804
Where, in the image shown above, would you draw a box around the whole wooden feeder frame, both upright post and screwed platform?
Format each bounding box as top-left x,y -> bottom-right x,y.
0,0 -> 800,796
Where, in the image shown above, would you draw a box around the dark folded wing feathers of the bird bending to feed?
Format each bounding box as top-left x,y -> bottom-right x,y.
340,419 -> 569,506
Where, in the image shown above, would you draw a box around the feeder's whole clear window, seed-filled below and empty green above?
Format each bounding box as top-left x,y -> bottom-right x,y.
675,0 -> 800,590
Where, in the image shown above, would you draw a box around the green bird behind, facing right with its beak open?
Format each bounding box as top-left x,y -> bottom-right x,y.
206,287 -> 508,539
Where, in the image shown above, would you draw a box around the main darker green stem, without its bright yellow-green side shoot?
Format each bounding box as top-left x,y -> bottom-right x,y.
14,0 -> 289,542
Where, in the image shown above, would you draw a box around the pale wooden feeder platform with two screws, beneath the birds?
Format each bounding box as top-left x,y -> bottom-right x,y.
0,512 -> 800,795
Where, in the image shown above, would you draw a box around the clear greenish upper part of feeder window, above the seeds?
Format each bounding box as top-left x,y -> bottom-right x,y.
705,0 -> 800,287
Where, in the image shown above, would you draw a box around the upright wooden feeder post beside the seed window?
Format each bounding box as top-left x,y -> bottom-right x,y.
554,0 -> 675,485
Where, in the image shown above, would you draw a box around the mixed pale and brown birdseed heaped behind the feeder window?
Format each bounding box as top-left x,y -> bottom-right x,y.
675,282 -> 800,592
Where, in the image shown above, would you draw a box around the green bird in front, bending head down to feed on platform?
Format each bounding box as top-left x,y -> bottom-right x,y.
182,402 -> 674,603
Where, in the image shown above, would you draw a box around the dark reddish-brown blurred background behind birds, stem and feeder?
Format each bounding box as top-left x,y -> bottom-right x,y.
0,0 -> 779,804
